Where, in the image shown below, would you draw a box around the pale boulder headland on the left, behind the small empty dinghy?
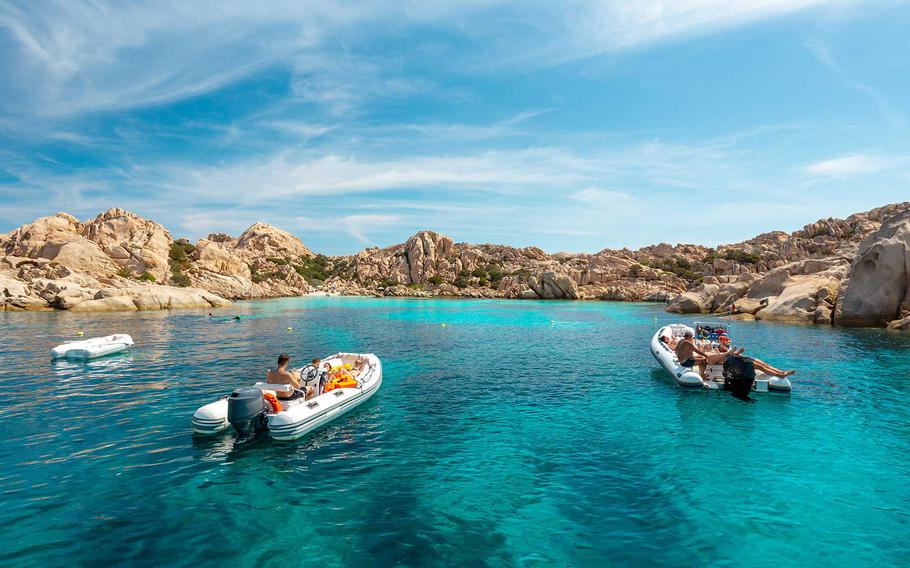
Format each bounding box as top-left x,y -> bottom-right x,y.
0,208 -> 316,311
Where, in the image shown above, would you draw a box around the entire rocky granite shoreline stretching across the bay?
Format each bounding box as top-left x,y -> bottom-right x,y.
0,203 -> 910,330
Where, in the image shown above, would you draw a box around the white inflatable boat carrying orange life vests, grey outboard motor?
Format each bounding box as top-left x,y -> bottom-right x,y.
193,353 -> 382,440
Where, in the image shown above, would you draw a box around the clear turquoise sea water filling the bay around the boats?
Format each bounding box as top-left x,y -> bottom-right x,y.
0,298 -> 910,566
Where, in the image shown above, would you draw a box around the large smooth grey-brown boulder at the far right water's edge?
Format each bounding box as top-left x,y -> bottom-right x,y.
835,210 -> 910,326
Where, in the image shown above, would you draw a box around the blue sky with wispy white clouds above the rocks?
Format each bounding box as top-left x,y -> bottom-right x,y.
0,0 -> 910,254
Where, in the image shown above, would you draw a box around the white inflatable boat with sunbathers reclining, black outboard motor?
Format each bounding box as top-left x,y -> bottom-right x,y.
651,323 -> 792,393
